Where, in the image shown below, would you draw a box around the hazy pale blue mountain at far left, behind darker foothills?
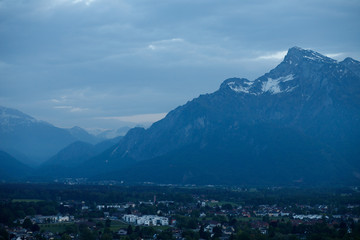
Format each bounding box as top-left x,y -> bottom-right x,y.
0,106 -> 101,165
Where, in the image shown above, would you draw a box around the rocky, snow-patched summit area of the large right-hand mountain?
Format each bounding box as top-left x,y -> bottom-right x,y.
220,47 -> 354,97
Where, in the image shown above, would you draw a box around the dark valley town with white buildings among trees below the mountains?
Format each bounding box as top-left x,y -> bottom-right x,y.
0,184 -> 360,240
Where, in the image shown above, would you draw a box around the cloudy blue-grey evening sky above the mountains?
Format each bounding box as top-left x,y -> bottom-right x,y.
0,0 -> 360,130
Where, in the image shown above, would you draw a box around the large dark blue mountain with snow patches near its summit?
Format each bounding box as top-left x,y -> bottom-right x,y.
78,47 -> 360,185
